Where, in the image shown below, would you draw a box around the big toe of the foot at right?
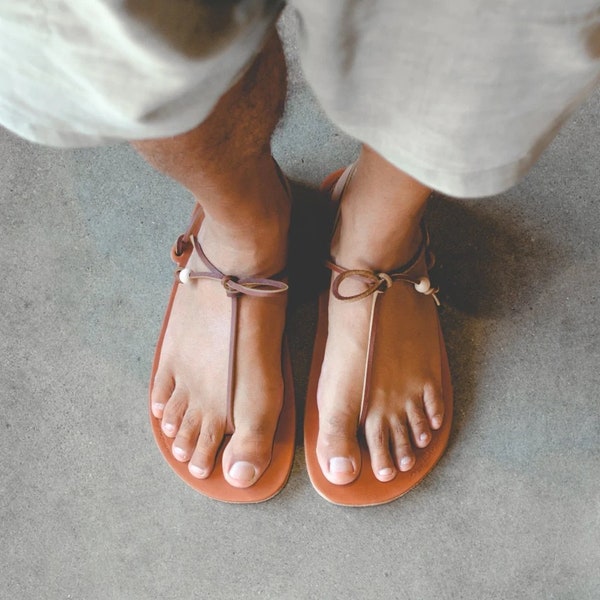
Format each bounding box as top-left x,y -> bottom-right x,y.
317,414 -> 360,485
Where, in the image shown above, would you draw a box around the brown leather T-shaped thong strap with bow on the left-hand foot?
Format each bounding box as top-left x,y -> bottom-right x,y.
173,205 -> 288,433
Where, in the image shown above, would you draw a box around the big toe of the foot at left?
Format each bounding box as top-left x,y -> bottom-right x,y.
223,422 -> 275,488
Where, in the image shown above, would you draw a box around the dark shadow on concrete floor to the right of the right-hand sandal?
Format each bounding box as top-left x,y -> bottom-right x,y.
426,195 -> 565,446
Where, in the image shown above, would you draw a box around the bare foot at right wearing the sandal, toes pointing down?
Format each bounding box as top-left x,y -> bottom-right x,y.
317,166 -> 444,485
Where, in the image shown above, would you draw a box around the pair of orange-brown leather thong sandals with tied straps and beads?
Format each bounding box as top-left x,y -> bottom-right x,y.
150,165 -> 452,506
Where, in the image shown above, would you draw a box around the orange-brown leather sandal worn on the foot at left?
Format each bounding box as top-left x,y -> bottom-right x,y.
149,195 -> 295,503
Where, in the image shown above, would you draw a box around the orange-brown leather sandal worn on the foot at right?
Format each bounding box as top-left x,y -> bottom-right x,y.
304,165 -> 453,506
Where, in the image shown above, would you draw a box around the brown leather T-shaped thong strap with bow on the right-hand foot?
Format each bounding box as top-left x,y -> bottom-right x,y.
325,226 -> 440,429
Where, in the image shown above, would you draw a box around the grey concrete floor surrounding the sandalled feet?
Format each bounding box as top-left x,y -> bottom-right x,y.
0,10 -> 600,600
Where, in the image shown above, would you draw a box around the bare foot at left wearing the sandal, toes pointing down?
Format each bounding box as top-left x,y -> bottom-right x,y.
151,189 -> 289,488
